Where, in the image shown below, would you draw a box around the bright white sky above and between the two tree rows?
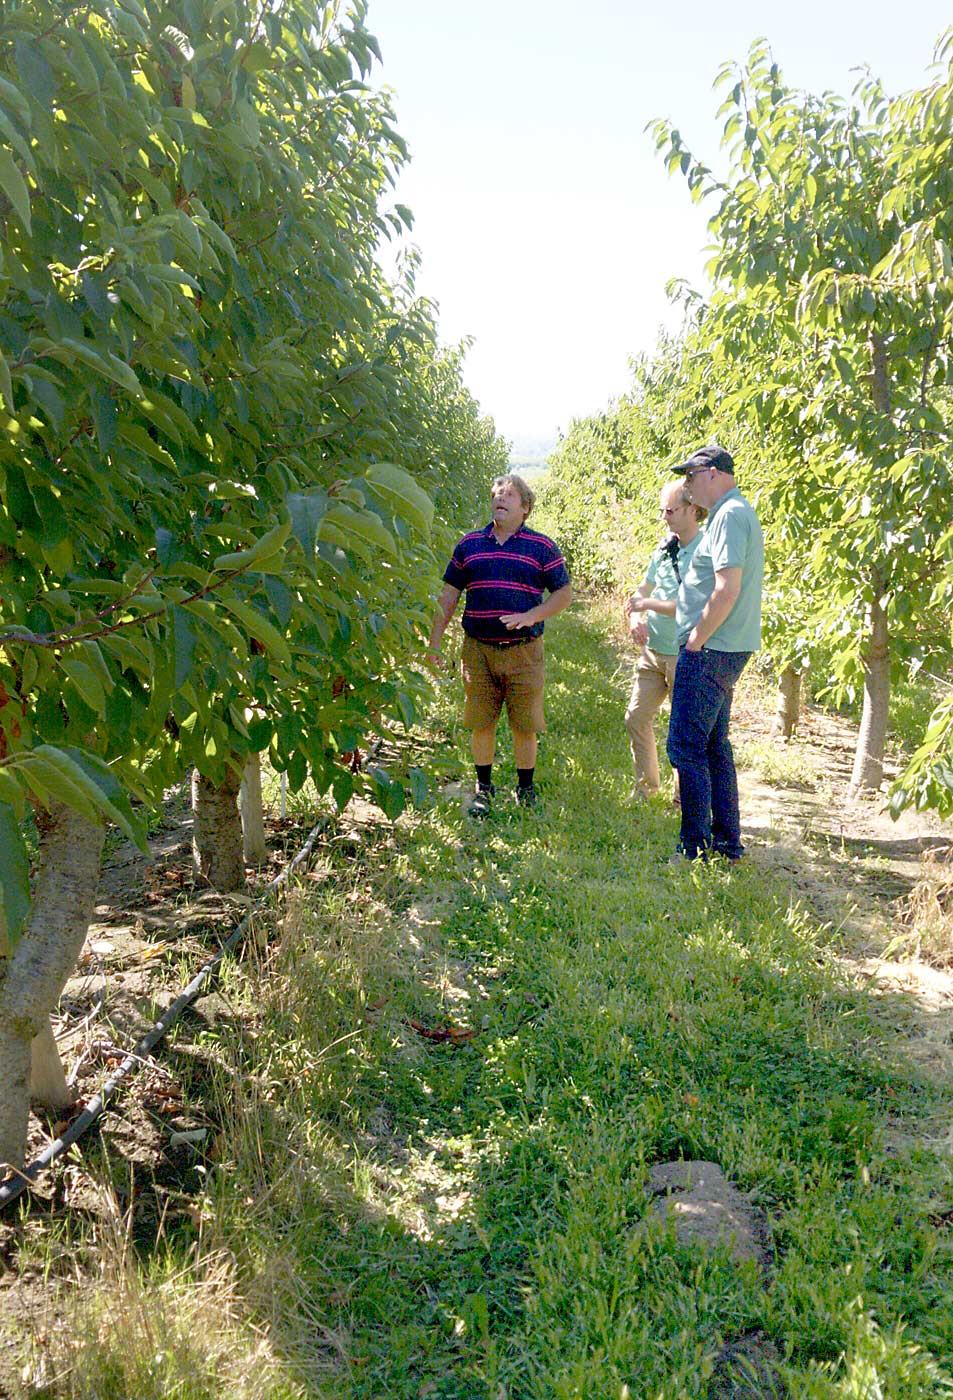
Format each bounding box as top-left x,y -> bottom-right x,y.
367,0 -> 953,454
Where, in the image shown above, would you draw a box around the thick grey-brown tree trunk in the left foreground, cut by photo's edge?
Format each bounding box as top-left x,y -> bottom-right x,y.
0,802 -> 105,1166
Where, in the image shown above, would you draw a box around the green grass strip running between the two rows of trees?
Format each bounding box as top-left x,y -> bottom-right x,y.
11,599 -> 953,1400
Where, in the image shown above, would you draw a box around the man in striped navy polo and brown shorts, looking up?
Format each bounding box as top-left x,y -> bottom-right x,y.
427,473 -> 572,816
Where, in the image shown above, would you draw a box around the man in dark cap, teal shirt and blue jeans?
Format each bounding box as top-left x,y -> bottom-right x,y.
668,445 -> 764,861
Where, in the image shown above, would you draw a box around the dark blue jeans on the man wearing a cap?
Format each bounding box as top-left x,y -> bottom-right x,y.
666,647 -> 751,860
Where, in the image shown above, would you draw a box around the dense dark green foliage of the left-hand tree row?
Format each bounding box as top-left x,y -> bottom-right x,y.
0,0 -> 505,934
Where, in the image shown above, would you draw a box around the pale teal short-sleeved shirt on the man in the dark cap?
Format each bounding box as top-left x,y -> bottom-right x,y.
675,486 -> 764,651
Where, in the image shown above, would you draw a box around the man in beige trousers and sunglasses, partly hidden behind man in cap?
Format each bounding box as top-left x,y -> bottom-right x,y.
626,482 -> 708,799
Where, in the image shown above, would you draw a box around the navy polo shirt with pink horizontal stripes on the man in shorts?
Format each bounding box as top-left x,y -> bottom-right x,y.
444,524 -> 570,641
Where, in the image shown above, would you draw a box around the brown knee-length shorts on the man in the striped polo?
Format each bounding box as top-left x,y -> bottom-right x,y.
463,636 -> 546,734
